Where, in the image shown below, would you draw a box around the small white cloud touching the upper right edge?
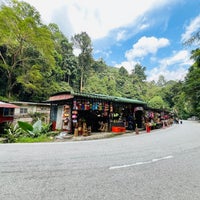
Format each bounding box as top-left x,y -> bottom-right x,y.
181,15 -> 200,42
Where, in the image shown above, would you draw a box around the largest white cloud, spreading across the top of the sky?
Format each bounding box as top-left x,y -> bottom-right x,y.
21,0 -> 173,39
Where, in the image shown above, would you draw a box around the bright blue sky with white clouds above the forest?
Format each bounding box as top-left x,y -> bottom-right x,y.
3,0 -> 200,81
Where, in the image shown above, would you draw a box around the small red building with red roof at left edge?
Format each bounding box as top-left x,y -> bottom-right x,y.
0,101 -> 18,134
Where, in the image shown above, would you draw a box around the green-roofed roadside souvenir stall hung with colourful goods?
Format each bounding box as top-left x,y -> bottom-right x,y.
48,92 -> 146,136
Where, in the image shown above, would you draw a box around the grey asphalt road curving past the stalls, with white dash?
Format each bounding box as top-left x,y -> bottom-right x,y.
0,121 -> 200,200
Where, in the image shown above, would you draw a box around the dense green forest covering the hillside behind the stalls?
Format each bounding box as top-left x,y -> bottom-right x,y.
0,0 -> 200,118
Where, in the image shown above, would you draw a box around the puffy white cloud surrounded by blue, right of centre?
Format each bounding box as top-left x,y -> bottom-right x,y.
125,36 -> 170,61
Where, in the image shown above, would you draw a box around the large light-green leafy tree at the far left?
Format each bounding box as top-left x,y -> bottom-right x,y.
0,0 -> 54,98
